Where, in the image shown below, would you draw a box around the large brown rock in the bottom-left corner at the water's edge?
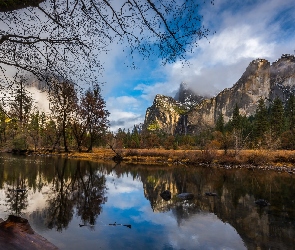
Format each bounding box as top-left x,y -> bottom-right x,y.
0,215 -> 58,250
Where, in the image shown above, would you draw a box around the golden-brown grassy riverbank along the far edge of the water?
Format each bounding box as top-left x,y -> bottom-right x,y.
36,148 -> 295,170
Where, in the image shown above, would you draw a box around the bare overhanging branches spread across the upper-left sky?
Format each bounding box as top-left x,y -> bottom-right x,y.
0,0 -> 214,83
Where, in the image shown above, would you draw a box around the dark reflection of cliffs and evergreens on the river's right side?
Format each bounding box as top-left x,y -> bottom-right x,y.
137,167 -> 295,249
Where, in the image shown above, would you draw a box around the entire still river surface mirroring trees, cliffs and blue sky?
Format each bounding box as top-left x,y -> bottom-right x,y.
0,155 -> 295,249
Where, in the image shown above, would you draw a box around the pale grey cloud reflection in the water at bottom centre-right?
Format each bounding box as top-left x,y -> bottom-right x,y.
132,206 -> 246,250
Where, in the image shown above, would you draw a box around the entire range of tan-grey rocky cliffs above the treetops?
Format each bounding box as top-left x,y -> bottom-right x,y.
144,55 -> 295,134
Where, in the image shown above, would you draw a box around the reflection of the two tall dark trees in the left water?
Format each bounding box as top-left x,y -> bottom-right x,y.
47,159 -> 106,231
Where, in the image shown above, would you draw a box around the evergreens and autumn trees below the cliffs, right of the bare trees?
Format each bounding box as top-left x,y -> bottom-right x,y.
115,95 -> 295,150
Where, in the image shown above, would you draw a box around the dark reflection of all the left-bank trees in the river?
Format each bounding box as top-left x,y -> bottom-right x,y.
0,155 -> 111,230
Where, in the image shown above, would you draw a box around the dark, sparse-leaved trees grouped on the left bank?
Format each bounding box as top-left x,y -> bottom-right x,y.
0,74 -> 109,152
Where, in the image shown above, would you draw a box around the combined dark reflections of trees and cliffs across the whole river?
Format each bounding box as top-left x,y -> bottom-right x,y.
0,154 -> 295,249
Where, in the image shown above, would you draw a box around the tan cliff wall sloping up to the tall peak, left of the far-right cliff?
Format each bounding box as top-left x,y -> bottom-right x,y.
187,59 -> 271,134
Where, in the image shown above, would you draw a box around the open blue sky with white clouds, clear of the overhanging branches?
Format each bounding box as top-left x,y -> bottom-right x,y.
100,0 -> 295,132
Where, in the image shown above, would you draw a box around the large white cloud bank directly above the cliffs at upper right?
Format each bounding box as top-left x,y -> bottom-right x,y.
143,0 -> 295,98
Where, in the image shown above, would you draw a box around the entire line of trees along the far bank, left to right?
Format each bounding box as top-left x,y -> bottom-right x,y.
4,74 -> 295,153
